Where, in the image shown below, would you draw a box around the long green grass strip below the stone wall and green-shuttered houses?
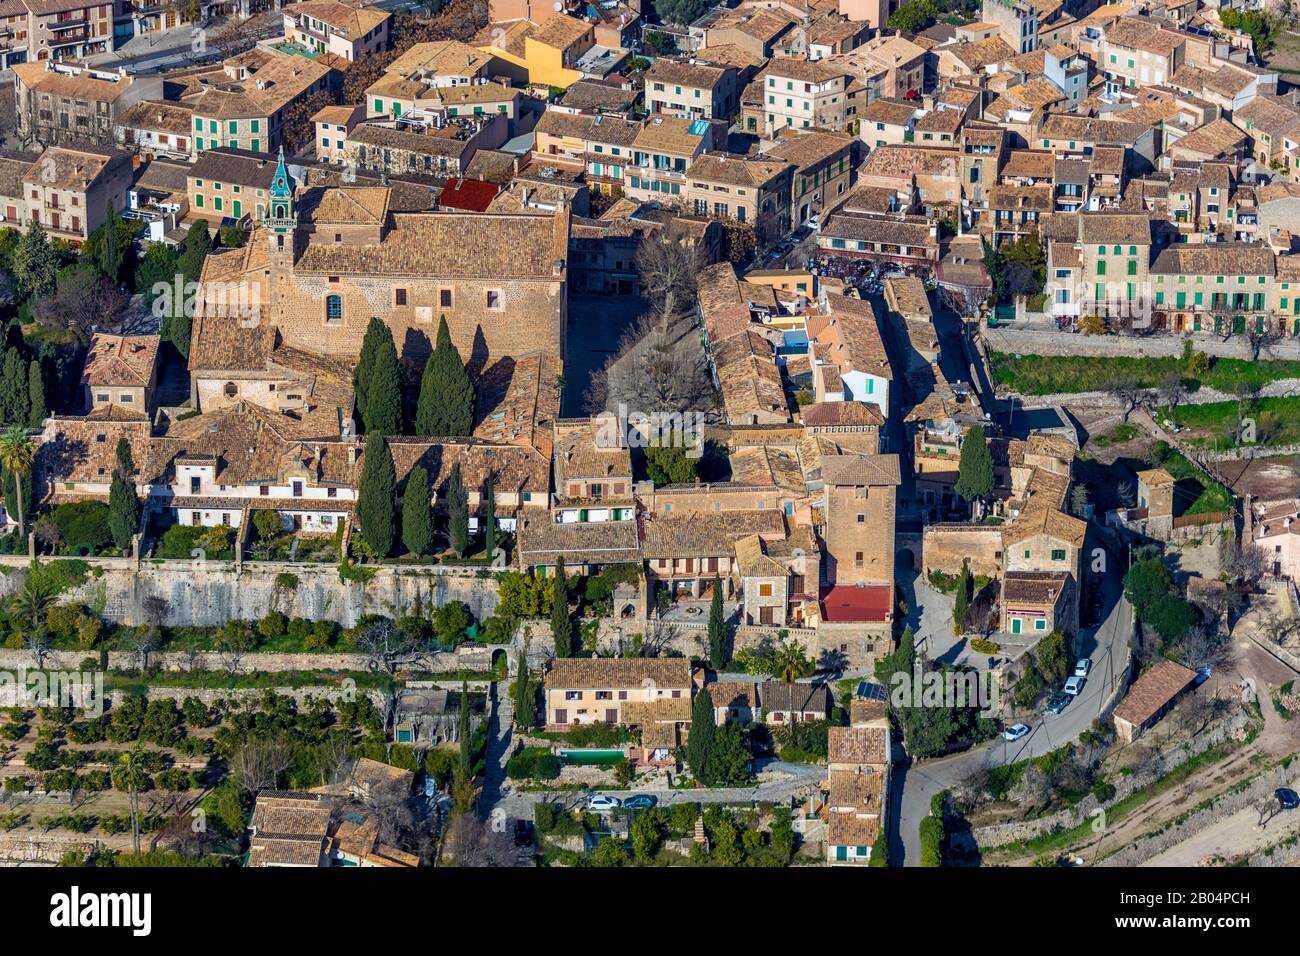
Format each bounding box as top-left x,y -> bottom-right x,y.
988,352 -> 1300,395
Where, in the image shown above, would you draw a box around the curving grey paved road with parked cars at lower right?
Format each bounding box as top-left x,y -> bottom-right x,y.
887,554 -> 1132,866
